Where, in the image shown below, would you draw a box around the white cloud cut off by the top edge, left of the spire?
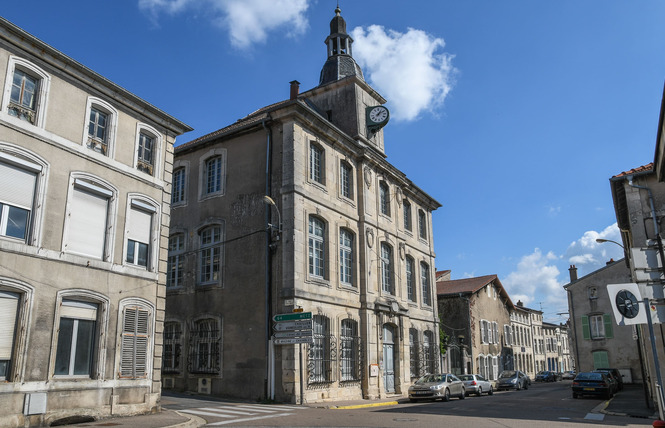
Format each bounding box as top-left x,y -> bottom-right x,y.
139,0 -> 311,49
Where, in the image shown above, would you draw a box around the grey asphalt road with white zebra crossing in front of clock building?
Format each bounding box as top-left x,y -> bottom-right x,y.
162,381 -> 653,428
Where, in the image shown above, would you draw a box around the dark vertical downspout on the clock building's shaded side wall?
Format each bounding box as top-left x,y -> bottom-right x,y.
261,115 -> 275,399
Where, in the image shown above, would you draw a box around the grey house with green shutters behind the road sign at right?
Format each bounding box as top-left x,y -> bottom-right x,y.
564,260 -> 643,383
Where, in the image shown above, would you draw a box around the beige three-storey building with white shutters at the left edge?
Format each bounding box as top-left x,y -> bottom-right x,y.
0,18 -> 191,427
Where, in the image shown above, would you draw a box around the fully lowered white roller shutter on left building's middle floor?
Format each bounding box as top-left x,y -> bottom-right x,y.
66,186 -> 109,259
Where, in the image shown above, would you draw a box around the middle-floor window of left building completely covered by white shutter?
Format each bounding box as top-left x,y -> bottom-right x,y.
64,178 -> 114,260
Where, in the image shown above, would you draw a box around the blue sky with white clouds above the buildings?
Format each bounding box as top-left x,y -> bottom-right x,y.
5,0 -> 665,321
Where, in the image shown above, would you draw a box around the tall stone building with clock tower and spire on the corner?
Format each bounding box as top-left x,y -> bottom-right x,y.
164,9 -> 440,403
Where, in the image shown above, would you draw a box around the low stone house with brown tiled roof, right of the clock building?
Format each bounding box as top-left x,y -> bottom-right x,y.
436,275 -> 517,380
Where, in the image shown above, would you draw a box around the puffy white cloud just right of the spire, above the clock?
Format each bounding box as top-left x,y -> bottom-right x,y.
351,25 -> 456,121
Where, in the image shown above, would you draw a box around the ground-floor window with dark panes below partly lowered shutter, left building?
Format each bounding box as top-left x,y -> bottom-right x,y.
54,299 -> 97,377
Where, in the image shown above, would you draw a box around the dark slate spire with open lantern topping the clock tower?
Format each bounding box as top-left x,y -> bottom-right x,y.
319,3 -> 365,86
